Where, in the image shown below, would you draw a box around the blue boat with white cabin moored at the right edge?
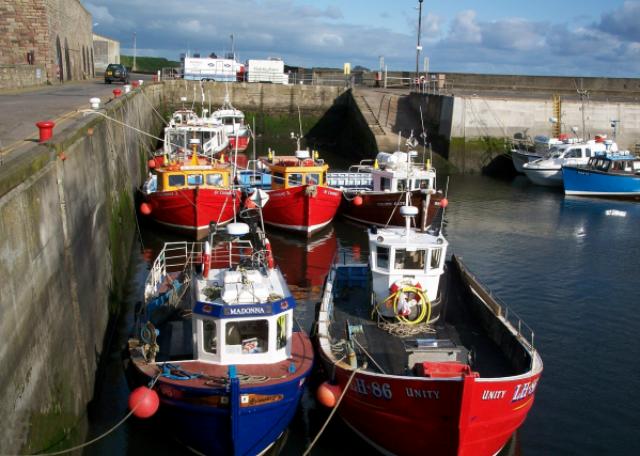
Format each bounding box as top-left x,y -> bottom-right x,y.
562,153 -> 640,197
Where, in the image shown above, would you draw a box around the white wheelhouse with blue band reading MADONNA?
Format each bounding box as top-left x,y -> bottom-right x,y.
192,237 -> 295,365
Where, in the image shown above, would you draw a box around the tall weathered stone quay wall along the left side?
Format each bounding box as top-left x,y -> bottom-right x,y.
0,85 -> 162,454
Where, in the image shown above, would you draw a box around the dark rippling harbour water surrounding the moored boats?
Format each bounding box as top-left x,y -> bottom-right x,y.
85,175 -> 640,456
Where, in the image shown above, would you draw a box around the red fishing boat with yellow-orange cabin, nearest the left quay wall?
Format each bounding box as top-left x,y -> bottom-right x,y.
140,139 -> 241,239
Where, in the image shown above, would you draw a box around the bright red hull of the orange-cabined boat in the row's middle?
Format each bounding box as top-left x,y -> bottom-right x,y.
262,185 -> 342,235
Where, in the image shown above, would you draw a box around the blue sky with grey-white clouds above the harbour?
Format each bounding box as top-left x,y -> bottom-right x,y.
82,0 -> 640,77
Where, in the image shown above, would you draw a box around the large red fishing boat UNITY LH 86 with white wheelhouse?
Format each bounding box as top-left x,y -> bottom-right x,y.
317,199 -> 542,456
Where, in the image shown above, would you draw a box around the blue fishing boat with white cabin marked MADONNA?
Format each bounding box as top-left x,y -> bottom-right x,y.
129,209 -> 313,456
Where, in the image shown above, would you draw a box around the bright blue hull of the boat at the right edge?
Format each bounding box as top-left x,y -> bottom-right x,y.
562,166 -> 640,196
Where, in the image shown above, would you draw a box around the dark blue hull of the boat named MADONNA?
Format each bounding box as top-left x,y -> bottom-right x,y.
152,372 -> 309,456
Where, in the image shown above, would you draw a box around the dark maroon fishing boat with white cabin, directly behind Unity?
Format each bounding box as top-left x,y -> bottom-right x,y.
327,146 -> 446,226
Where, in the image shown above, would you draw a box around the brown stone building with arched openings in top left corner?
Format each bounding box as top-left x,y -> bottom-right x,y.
0,0 -> 94,88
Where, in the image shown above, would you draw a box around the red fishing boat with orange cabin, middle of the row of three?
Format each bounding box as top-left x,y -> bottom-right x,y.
256,150 -> 342,236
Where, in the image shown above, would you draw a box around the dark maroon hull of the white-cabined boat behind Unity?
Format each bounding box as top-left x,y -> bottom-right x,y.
340,191 -> 443,226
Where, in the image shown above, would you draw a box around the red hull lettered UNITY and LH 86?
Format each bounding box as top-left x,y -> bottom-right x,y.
323,366 -> 540,456
